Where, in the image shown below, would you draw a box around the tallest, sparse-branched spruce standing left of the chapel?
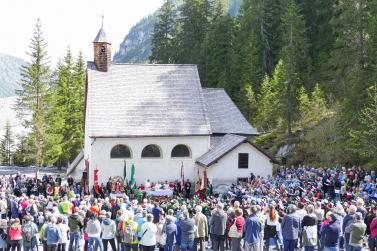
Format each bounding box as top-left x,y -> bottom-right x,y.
17,19 -> 50,168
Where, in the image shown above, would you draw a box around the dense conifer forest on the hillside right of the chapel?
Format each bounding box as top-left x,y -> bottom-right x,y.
150,0 -> 377,167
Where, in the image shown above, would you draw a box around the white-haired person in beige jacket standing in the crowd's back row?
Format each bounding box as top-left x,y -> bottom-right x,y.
194,205 -> 208,251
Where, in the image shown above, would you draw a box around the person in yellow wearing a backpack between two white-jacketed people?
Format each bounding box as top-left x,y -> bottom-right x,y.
120,215 -> 139,251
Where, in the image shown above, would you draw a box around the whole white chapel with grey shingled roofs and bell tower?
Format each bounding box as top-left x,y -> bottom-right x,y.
67,24 -> 273,187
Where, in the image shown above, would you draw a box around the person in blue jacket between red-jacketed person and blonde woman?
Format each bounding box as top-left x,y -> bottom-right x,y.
244,206 -> 262,251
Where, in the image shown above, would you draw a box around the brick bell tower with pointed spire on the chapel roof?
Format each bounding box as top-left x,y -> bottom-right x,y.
93,16 -> 111,72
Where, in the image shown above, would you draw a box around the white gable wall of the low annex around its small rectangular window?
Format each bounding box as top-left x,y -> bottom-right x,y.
207,143 -> 273,184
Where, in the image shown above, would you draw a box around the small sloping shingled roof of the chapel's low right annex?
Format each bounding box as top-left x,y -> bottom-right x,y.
196,134 -> 248,167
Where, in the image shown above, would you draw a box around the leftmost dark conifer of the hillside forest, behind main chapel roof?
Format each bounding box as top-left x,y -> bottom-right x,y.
149,0 -> 176,64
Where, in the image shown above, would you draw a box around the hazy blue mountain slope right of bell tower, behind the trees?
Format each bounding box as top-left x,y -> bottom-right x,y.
113,0 -> 242,63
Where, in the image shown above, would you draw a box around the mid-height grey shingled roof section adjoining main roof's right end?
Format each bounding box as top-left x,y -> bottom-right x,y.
203,88 -> 259,135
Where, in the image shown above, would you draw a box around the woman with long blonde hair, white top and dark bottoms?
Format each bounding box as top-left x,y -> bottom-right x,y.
264,206 -> 281,251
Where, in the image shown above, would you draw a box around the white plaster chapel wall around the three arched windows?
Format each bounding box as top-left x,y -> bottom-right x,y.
89,136 -> 209,187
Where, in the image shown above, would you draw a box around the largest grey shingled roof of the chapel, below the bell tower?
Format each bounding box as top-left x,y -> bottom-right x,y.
87,62 -> 211,137
